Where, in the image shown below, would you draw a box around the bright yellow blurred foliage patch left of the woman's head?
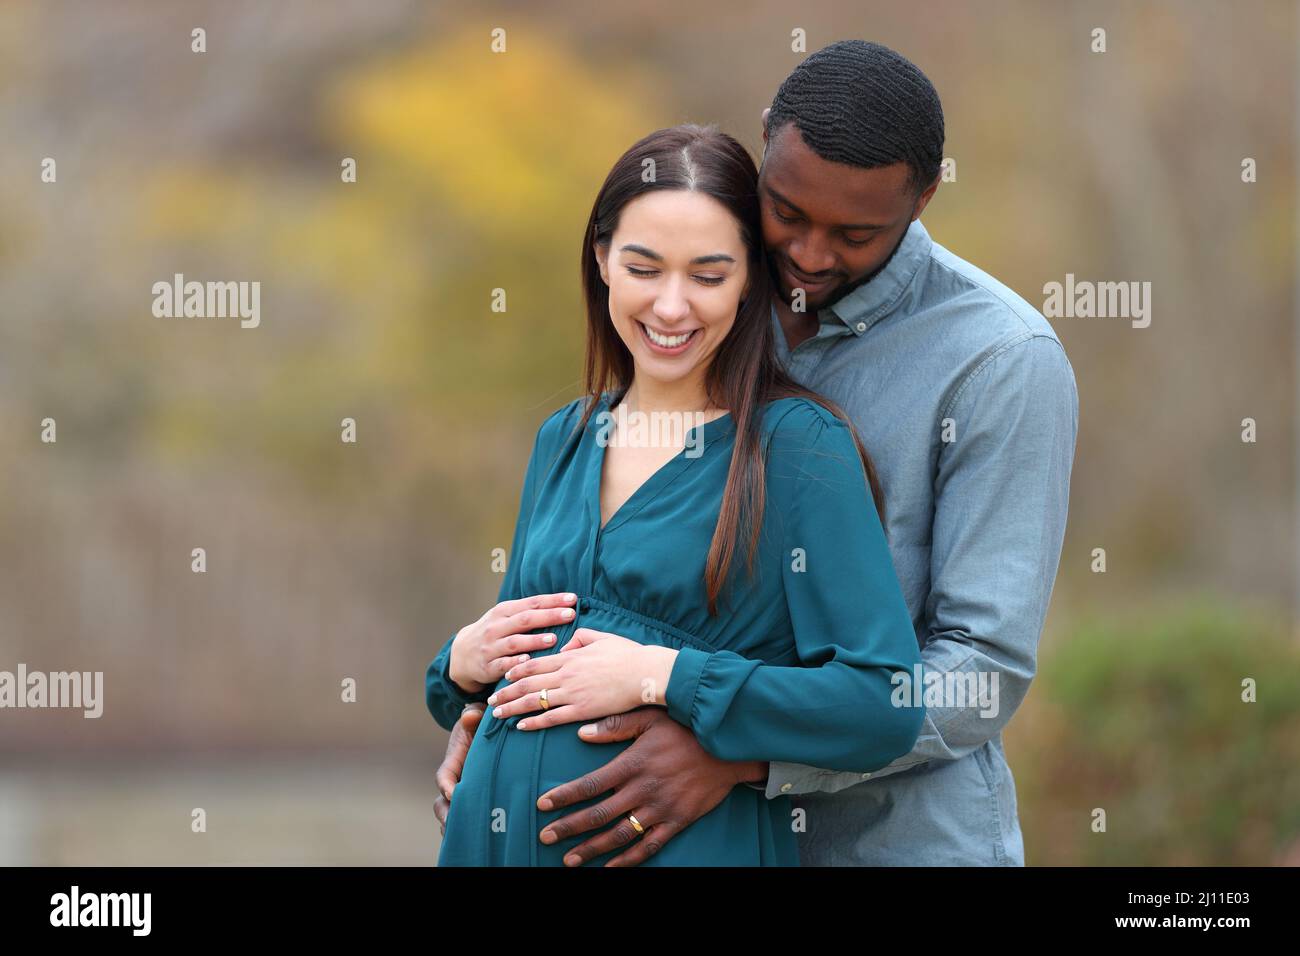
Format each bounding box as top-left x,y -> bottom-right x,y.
328,26 -> 664,237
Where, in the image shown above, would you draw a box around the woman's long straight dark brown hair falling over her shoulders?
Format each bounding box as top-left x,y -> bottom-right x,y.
576,124 -> 884,615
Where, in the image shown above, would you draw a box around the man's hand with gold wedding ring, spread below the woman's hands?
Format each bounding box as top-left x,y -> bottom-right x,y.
537,708 -> 767,866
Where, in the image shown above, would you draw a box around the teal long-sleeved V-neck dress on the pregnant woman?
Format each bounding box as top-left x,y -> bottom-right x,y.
425,394 -> 924,866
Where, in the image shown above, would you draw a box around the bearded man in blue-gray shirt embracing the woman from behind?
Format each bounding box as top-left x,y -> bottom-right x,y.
436,40 -> 1078,866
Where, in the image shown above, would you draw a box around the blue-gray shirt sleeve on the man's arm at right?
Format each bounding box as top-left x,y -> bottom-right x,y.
766,336 -> 1079,797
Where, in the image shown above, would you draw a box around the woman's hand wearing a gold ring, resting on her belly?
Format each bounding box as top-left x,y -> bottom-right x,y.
488,627 -> 677,730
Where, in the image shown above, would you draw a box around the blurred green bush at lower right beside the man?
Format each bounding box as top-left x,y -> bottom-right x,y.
1006,601 -> 1300,866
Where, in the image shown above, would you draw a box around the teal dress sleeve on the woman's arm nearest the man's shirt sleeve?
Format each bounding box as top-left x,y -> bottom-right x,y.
664,406 -> 924,771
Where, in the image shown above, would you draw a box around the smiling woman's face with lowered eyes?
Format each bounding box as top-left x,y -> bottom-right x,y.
595,190 -> 749,398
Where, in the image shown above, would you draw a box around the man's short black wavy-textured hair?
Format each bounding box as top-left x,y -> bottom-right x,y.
767,40 -> 944,195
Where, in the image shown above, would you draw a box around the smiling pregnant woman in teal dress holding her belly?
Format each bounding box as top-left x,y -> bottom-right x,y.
425,126 -> 924,866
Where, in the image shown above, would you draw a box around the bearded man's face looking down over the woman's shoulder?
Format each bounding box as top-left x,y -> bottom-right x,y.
758,112 -> 939,313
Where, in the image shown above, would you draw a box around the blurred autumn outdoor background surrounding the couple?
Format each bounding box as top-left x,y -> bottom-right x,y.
0,0 -> 1300,865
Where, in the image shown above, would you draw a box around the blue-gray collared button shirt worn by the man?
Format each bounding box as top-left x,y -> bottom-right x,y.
766,220 -> 1079,866
